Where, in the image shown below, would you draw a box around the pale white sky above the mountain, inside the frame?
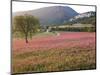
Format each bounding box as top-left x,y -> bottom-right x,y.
12,1 -> 95,13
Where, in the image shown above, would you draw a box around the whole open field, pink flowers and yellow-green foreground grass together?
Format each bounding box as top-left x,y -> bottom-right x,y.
12,32 -> 96,73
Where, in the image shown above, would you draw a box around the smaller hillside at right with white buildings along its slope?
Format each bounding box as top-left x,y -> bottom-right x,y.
65,11 -> 96,25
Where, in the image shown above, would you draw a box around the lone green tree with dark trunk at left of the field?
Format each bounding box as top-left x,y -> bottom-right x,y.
14,15 -> 39,43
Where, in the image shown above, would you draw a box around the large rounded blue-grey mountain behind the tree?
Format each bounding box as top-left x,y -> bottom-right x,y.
13,6 -> 78,25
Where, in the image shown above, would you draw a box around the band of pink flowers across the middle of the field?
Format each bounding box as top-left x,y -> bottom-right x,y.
13,32 -> 95,50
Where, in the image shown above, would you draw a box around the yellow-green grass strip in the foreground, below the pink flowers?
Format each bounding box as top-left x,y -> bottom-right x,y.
12,47 -> 96,73
